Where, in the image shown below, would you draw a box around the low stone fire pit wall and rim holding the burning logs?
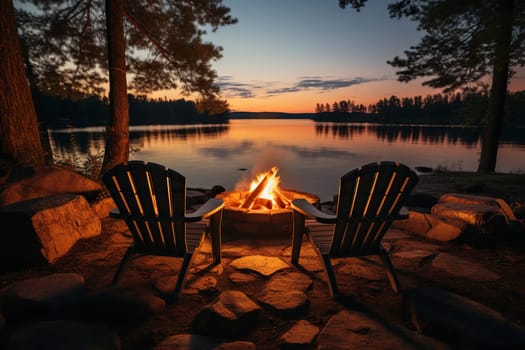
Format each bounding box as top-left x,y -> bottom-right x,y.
217,190 -> 320,240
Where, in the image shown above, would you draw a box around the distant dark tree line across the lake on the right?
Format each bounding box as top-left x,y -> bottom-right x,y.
315,91 -> 525,126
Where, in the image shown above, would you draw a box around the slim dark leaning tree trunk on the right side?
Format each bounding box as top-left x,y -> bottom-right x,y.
478,0 -> 514,173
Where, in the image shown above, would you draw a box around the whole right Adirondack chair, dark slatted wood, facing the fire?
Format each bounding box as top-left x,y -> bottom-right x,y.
292,162 -> 418,298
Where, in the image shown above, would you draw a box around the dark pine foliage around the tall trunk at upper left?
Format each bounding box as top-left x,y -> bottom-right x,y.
18,0 -> 237,97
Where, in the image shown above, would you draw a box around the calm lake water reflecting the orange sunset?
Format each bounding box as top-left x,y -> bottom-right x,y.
50,119 -> 525,201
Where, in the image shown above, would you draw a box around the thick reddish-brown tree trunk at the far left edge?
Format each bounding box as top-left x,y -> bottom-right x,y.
0,0 -> 44,165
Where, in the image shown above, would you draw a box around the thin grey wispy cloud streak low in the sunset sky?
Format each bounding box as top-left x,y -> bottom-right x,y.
217,76 -> 392,98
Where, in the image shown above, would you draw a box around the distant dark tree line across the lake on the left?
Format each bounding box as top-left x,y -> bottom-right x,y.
35,94 -> 228,127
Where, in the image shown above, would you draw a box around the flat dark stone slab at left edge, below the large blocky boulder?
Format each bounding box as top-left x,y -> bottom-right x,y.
1,273 -> 86,308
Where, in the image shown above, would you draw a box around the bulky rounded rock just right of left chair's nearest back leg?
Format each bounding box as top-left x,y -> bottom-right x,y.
193,290 -> 261,337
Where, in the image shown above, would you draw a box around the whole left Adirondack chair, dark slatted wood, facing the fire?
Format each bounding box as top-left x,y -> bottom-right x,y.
102,161 -> 224,297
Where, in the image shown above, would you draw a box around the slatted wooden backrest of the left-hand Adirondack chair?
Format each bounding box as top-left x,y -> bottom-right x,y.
102,161 -> 186,256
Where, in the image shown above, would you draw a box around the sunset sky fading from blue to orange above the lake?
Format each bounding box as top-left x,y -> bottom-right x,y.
161,0 -> 525,113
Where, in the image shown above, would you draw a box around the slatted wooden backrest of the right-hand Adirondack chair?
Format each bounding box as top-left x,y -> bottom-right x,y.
330,162 -> 418,256
